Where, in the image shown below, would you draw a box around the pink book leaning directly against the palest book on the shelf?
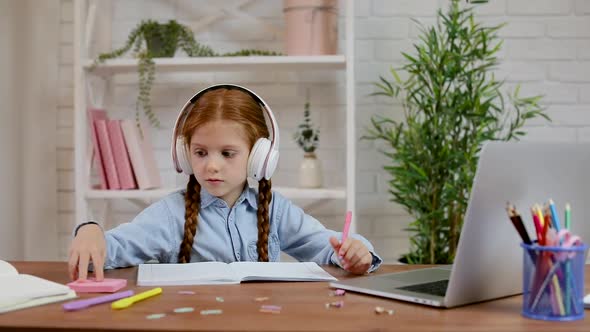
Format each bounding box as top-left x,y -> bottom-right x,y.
107,120 -> 137,189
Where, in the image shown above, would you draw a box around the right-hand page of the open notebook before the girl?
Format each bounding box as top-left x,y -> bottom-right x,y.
229,262 -> 338,281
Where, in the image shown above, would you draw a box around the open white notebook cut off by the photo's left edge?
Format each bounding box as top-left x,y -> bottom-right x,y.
0,260 -> 76,313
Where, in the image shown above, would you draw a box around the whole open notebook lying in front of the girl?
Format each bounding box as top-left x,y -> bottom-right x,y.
137,262 -> 337,286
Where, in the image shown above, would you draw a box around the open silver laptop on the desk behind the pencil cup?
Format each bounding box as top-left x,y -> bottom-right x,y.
330,142 -> 590,308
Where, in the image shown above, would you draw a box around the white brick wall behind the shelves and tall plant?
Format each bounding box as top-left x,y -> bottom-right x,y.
56,0 -> 590,262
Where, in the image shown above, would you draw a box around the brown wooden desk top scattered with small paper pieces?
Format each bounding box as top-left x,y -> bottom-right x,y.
0,262 -> 590,332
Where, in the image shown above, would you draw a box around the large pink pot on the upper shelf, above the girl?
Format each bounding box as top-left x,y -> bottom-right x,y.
283,0 -> 338,55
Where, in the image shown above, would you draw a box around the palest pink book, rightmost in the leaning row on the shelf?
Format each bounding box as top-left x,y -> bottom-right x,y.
121,120 -> 161,189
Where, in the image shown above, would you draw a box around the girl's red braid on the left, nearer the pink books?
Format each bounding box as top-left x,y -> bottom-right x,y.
178,174 -> 201,263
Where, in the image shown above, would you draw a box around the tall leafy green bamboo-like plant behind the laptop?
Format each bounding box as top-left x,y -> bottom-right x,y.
364,0 -> 550,264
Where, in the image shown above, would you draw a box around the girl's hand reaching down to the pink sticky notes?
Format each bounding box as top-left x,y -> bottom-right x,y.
68,224 -> 106,281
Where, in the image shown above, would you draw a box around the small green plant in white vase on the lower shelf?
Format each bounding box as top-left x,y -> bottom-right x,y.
293,92 -> 322,188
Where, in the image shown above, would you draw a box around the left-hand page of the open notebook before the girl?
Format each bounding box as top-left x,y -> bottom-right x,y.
137,262 -> 240,286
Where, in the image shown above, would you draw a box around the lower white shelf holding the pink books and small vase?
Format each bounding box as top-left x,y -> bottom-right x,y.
86,187 -> 346,199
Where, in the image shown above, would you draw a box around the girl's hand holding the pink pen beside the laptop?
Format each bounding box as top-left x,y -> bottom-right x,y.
330,236 -> 373,274
